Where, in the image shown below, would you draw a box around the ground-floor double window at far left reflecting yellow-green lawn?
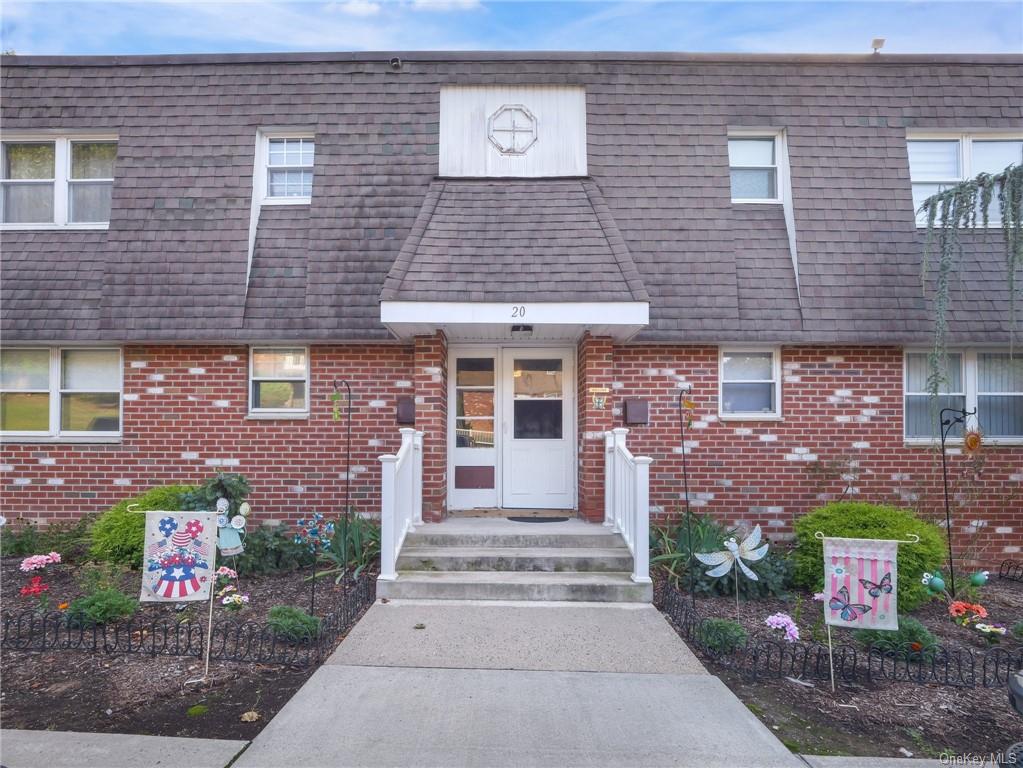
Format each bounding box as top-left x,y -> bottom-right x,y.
0,347 -> 123,438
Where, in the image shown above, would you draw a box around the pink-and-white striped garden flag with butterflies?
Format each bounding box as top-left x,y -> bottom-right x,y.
825,537 -> 898,630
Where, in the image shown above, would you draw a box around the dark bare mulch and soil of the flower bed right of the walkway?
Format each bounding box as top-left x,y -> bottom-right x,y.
657,578 -> 1023,757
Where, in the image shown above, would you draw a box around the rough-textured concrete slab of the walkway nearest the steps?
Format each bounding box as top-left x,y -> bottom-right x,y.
327,600 -> 707,675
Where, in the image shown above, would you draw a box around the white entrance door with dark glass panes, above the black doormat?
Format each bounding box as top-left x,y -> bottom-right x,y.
500,349 -> 575,509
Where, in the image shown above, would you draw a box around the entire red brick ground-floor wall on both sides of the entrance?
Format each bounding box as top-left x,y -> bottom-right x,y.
0,336 -> 1023,563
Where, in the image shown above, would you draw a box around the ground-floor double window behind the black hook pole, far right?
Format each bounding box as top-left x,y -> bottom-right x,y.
904,350 -> 1023,443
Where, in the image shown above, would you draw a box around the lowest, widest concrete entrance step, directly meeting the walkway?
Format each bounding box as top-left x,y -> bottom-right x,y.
376,571 -> 654,602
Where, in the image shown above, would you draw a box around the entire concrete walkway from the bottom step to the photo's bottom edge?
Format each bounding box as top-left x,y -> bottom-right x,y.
235,600 -> 806,768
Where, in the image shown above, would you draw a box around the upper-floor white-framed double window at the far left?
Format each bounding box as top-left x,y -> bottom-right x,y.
0,136 -> 118,229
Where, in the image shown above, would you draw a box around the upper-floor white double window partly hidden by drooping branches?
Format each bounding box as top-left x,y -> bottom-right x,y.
906,133 -> 1023,226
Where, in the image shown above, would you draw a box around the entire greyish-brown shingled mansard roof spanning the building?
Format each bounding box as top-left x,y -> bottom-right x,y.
0,53 -> 1023,344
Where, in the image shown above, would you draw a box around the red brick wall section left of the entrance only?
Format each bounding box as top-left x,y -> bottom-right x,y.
0,345 -> 422,521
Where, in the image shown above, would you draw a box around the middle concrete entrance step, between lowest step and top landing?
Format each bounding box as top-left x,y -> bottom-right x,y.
398,544 -> 632,573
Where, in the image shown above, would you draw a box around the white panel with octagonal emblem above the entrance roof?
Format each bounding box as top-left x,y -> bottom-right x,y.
439,86 -> 586,178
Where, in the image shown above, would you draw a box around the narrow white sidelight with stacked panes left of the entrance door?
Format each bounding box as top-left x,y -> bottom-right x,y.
448,350 -> 498,509
